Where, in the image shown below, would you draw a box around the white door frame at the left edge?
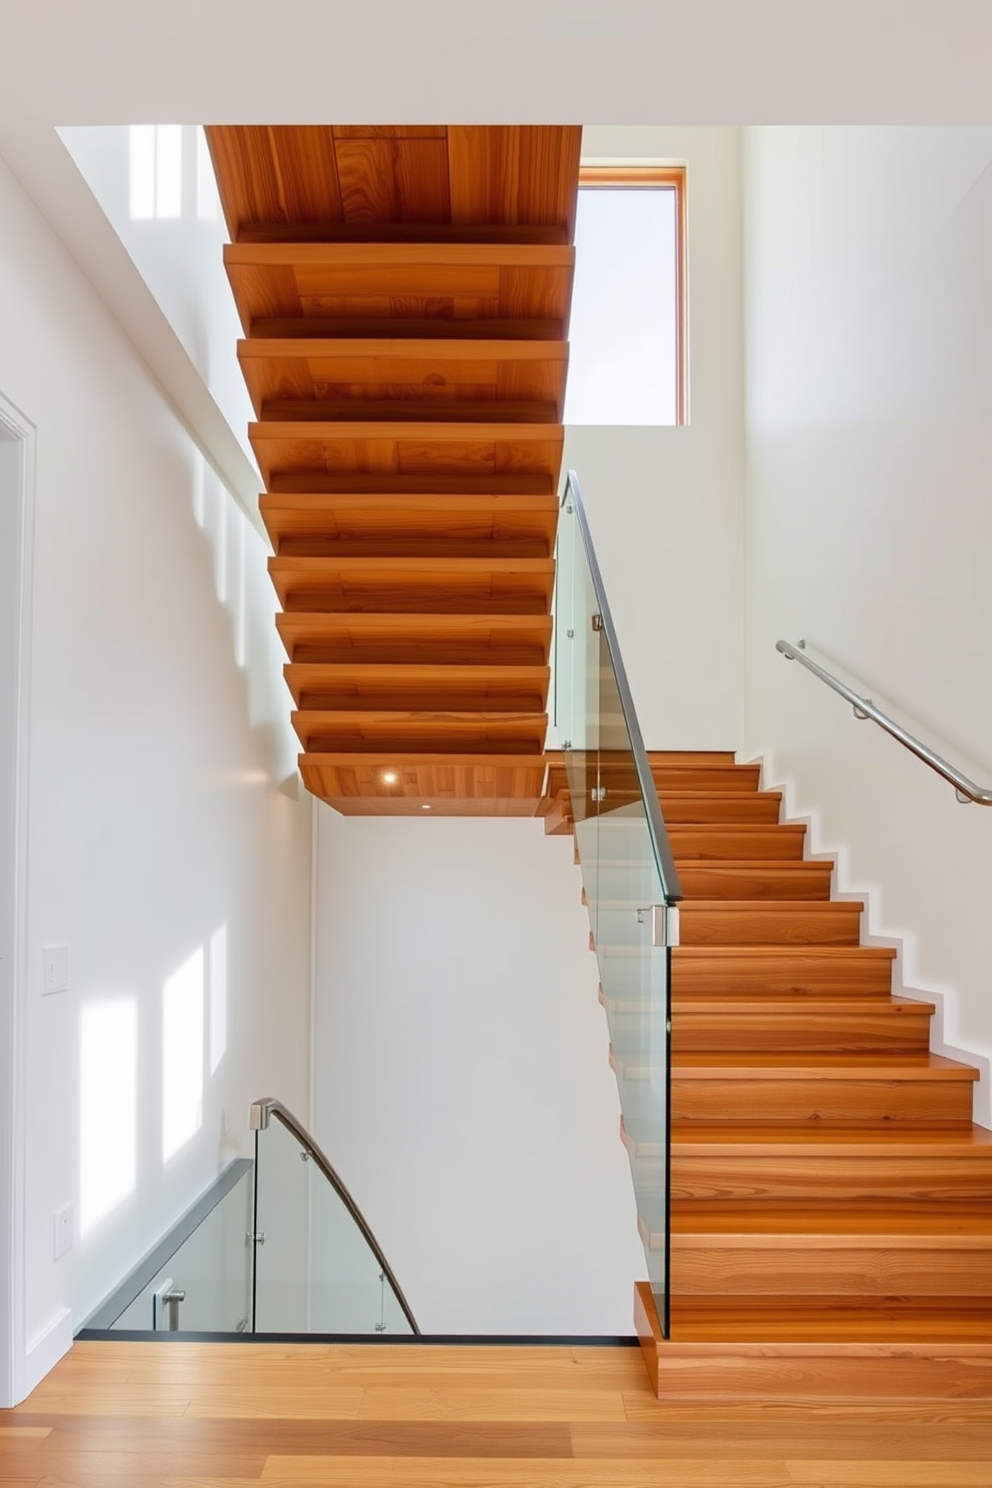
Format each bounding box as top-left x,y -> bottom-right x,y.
0,393 -> 37,1406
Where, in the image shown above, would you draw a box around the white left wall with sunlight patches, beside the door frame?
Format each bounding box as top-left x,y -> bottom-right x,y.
0,151 -> 311,1385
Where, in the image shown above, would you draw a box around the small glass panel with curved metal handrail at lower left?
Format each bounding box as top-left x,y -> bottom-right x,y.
248,1098 -> 419,1335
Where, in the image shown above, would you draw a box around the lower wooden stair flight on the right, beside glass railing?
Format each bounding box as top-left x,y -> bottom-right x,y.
544,753 -> 992,1400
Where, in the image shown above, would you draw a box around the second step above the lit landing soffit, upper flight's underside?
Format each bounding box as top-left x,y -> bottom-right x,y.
283,662 -> 550,713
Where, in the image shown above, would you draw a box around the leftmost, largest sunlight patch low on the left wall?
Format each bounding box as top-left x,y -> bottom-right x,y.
79,997 -> 138,1235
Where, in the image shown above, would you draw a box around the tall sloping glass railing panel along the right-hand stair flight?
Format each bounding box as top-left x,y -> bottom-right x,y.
555,470 -> 683,1338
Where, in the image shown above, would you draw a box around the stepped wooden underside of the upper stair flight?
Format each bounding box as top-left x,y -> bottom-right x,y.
207,125 -> 582,815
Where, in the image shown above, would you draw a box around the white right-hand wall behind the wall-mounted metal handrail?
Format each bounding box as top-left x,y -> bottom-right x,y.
744,128 -> 992,1123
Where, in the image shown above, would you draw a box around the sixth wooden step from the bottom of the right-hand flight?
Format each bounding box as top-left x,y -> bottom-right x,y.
672,945 -> 895,1003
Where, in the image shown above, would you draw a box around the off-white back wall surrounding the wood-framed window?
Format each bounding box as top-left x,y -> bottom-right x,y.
565,126 -> 744,748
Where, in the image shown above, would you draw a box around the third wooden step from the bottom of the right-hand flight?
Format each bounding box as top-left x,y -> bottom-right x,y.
660,1126 -> 992,1208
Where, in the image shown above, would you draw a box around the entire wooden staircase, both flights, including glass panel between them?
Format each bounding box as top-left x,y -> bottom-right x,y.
208,126 -> 992,1399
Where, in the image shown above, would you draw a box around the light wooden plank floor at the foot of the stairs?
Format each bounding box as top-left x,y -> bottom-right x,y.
0,1342 -> 992,1488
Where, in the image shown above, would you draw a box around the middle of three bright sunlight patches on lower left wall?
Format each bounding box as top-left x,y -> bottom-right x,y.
162,948 -> 204,1162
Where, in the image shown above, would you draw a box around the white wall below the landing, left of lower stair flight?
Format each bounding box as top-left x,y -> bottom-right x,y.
314,806 -> 644,1335
